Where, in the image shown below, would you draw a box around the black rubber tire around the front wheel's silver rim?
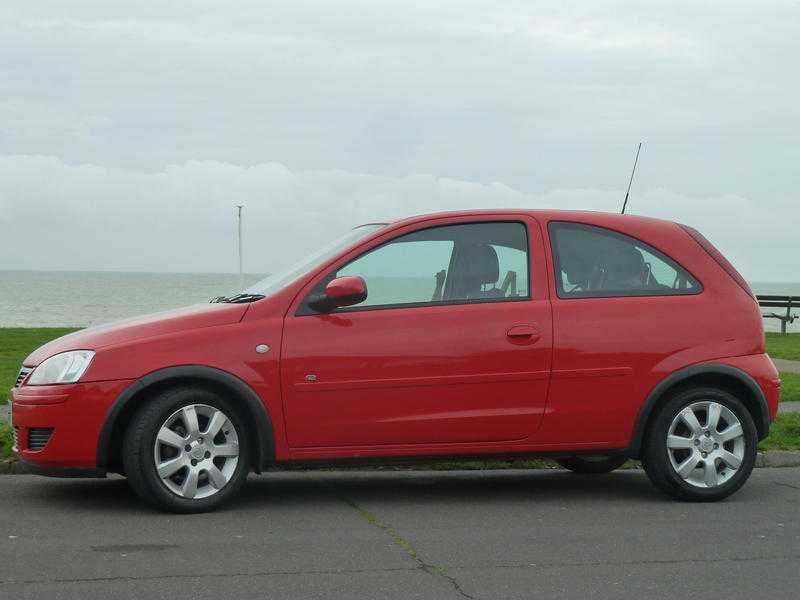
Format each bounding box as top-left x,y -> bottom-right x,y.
123,387 -> 250,513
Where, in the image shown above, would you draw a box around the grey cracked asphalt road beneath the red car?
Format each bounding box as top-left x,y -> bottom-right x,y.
0,468 -> 800,600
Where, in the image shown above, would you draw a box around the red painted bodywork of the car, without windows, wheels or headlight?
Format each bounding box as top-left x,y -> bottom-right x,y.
12,210 -> 779,474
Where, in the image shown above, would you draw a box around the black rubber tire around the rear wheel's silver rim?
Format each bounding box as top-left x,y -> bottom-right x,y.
642,387 -> 758,502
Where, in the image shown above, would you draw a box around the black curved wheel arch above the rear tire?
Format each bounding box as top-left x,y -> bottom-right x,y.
628,363 -> 769,458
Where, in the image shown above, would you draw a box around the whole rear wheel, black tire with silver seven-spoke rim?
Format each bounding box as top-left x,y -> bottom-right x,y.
642,387 -> 758,502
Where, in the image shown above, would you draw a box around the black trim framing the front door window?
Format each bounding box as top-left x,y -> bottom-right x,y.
295,219 -> 546,317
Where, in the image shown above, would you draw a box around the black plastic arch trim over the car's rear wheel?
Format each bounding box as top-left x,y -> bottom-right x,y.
628,363 -> 770,457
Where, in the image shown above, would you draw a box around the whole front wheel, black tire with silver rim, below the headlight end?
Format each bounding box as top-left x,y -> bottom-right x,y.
123,388 -> 249,512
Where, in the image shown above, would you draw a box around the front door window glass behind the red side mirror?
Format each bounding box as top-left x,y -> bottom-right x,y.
312,222 -> 529,311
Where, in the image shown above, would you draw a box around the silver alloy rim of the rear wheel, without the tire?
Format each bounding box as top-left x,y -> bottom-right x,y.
667,400 -> 745,488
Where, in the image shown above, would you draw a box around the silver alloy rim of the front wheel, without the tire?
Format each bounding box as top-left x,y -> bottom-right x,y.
153,404 -> 239,499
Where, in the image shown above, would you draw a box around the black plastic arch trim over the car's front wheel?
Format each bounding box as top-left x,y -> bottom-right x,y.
97,365 -> 275,473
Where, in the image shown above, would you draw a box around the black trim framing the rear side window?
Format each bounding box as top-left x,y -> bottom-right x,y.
547,220 -> 705,300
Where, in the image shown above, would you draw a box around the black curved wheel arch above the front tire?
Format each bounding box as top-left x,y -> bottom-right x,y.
97,365 -> 275,473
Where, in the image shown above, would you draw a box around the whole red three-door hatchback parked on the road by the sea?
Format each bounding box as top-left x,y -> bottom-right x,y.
12,210 -> 780,512
